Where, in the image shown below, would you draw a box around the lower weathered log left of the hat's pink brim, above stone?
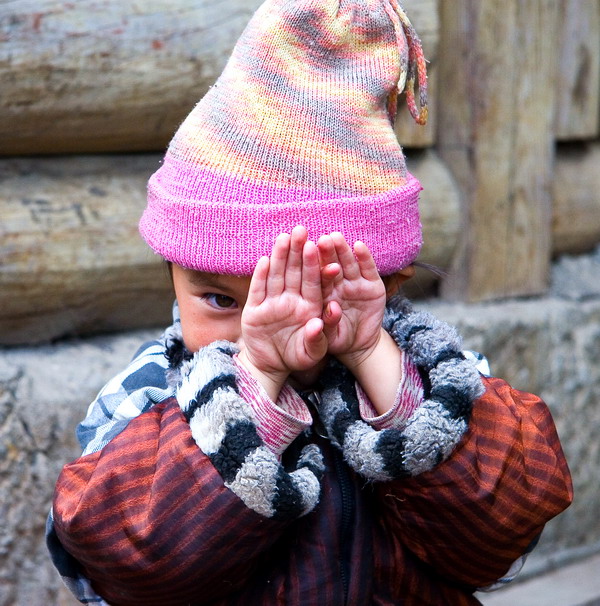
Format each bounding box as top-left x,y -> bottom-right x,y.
0,156 -> 173,345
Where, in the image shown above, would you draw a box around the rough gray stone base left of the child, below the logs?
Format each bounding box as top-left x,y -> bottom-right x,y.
0,333 -> 161,606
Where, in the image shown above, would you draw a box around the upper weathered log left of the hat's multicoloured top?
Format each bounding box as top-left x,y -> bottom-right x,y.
0,0 -> 260,155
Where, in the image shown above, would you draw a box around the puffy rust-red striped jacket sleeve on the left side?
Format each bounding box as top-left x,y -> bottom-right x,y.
54,400 -> 296,606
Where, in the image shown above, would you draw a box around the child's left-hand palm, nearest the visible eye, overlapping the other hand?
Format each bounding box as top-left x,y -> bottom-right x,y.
239,226 -> 327,400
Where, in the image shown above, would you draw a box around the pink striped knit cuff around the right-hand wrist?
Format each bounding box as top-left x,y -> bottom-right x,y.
356,352 -> 423,430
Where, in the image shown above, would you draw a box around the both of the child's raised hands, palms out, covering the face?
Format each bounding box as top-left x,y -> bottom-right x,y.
239,226 -> 400,413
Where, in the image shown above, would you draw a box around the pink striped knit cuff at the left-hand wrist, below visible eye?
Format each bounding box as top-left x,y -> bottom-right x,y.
234,356 -> 312,457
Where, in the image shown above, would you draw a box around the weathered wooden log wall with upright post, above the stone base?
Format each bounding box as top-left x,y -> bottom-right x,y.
0,0 -> 600,344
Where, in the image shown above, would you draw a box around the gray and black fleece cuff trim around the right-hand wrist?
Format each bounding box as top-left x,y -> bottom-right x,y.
319,297 -> 484,481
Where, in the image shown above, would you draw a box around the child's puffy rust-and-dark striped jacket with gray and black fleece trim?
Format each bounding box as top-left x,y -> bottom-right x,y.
48,300 -> 572,606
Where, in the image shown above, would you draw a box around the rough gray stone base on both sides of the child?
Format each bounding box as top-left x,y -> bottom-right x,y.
0,251 -> 600,606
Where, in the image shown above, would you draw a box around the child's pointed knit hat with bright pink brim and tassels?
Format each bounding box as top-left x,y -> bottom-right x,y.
140,0 -> 427,275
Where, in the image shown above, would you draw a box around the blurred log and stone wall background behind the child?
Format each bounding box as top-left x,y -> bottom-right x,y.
0,0 -> 600,606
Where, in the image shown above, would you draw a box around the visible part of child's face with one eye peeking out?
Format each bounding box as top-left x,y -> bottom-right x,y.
172,264 -> 251,352
